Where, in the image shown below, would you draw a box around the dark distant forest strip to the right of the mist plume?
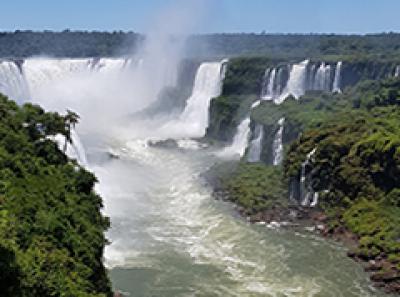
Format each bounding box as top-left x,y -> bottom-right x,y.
189,32 -> 400,59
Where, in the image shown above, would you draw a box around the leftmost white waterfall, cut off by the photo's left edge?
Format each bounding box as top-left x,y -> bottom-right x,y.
0,61 -> 29,102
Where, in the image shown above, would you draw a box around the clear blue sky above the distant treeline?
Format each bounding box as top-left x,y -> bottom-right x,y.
0,0 -> 400,33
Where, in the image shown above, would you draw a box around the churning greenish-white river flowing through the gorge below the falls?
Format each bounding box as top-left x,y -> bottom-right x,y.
89,140 -> 383,297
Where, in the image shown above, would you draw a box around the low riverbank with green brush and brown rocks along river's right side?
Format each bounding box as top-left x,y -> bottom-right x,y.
206,162 -> 400,294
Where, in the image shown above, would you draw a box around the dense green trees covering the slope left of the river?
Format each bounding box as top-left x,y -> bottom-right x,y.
0,95 -> 111,297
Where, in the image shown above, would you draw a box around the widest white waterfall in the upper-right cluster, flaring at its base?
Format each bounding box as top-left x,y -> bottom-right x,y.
275,60 -> 310,104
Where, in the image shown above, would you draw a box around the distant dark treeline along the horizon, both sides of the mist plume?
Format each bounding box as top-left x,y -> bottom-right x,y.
0,30 -> 400,59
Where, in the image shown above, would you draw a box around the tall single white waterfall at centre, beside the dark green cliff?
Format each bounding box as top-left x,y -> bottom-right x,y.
178,60 -> 226,137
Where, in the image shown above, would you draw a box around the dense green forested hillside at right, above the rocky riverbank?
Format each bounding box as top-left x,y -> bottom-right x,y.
285,80 -> 400,290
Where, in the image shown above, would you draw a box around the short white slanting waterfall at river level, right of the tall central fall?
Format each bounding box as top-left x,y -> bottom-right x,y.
218,117 -> 250,157
